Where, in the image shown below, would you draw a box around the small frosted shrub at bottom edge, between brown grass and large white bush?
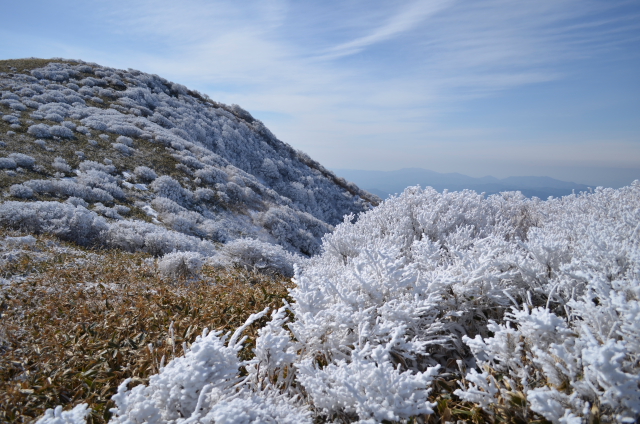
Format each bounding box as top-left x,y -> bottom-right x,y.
107,318 -> 312,424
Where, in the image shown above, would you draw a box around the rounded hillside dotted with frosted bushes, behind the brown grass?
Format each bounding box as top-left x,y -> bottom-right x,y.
0,59 -> 379,272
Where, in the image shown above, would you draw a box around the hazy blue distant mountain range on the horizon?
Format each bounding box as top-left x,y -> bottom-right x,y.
333,168 -> 589,199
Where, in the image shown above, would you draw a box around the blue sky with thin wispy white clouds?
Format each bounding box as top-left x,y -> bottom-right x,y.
0,0 -> 640,186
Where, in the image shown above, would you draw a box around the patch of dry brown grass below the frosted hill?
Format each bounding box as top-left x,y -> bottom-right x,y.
0,231 -> 288,423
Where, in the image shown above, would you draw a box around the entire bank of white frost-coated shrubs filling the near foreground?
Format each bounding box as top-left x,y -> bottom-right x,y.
42,182 -> 640,424
